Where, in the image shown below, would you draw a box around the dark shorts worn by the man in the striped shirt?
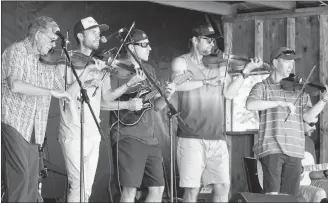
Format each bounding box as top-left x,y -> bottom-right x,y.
260,154 -> 302,196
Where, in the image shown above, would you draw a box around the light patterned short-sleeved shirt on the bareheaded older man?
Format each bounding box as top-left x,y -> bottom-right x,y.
1,38 -> 64,144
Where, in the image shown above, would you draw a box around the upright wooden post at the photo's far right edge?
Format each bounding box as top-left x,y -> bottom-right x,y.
319,15 -> 328,163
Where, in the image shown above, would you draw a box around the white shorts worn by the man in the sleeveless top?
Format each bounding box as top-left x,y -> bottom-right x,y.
177,137 -> 230,188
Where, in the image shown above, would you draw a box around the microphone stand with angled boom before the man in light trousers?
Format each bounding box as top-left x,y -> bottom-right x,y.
61,36 -> 105,202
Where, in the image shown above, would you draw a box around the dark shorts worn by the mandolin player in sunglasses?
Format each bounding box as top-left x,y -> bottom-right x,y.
113,138 -> 165,188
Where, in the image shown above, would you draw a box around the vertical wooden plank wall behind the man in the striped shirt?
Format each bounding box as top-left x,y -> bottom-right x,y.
225,13 -> 328,194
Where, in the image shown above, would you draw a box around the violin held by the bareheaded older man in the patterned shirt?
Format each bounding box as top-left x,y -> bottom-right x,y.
39,49 -> 115,70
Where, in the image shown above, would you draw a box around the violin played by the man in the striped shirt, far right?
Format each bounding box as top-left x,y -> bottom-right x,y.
280,73 -> 326,96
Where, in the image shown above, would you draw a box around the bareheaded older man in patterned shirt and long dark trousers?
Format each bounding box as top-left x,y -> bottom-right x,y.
1,16 -> 71,202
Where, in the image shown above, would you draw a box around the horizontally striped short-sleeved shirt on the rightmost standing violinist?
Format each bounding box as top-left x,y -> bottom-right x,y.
248,77 -> 312,158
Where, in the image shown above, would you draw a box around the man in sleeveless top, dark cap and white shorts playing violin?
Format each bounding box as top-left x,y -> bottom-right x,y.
172,25 -> 263,202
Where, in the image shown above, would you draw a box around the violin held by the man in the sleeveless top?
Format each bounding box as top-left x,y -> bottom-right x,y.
203,52 -> 271,73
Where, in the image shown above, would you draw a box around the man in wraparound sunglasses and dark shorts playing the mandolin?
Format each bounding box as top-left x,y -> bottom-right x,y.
102,29 -> 175,202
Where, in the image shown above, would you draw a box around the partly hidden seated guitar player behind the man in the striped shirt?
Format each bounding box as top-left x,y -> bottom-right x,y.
300,118 -> 328,202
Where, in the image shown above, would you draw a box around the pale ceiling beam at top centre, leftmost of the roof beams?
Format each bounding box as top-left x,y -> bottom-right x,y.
151,0 -> 237,15
